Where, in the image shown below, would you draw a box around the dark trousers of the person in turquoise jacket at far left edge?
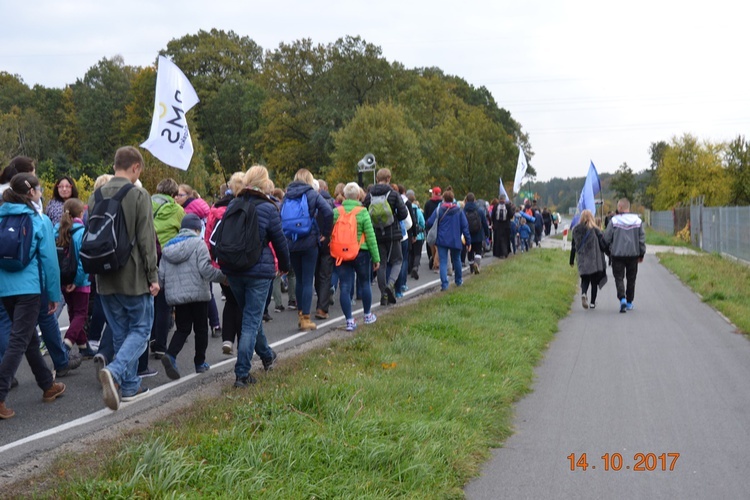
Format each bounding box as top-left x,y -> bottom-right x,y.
0,294 -> 54,402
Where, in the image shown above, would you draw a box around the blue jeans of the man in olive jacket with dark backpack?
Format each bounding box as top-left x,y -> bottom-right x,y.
100,293 -> 154,397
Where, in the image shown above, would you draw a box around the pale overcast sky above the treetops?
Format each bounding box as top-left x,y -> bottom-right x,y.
0,0 -> 750,181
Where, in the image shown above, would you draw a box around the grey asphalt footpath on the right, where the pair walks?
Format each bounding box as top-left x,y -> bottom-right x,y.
465,249 -> 750,499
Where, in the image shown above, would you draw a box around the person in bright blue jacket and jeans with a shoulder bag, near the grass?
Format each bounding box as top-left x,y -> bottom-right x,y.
426,190 -> 471,290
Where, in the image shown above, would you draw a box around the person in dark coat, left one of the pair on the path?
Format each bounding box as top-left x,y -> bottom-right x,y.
570,210 -> 607,309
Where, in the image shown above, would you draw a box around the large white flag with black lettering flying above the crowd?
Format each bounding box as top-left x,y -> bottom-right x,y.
141,56 -> 199,170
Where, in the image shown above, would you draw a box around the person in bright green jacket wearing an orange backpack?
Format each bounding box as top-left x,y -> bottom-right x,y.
331,182 -> 380,331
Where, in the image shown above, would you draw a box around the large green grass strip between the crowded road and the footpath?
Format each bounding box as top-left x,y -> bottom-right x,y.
17,250 -> 578,499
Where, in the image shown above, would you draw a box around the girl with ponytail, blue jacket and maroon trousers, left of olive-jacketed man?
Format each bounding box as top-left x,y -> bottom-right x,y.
55,198 -> 96,359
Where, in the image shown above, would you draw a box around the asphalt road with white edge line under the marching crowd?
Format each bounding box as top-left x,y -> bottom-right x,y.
0,248 -> 492,474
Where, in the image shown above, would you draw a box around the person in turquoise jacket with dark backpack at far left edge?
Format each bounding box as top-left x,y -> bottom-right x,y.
0,173 -> 65,419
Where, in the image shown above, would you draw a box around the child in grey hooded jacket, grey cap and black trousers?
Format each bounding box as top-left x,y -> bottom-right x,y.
159,214 -> 226,380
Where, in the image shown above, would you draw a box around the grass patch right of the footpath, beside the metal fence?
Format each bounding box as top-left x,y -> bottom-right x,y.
659,253 -> 750,335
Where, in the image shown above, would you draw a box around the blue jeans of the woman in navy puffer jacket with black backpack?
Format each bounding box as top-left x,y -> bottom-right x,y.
229,274 -> 276,378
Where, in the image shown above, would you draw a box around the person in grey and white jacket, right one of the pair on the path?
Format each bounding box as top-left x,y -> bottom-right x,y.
604,198 -> 646,313
